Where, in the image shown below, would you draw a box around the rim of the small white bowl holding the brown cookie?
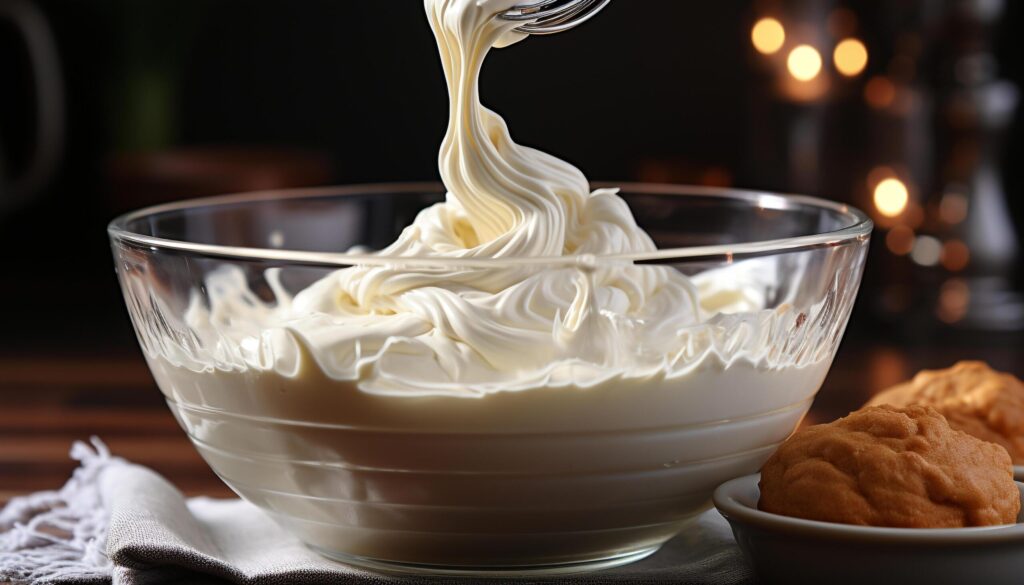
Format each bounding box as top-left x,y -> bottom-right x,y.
712,473 -> 1024,545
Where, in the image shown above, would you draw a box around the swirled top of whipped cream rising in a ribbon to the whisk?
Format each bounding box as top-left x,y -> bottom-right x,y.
178,0 -> 815,396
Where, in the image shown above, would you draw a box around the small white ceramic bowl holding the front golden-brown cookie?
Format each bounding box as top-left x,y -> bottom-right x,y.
714,474 -> 1024,585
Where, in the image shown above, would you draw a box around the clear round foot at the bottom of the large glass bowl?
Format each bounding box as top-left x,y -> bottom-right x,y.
307,544 -> 662,578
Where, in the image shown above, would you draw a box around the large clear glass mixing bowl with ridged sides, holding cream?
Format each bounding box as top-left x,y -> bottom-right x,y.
109,183 -> 871,575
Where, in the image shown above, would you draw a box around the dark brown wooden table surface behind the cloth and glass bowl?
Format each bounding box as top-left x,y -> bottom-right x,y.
0,346 -> 1024,501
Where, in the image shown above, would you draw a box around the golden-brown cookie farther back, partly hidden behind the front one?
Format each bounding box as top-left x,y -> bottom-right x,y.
867,362 -> 1024,464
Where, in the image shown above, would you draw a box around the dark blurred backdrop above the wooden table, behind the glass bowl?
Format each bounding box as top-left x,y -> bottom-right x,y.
0,0 -> 1024,353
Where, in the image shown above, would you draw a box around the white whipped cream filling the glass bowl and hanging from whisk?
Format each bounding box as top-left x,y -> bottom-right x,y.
134,0 -> 856,571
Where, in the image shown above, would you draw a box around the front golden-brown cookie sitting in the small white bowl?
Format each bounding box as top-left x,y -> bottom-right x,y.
758,406 -> 1020,528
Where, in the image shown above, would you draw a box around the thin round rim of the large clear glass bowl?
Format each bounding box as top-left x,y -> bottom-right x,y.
106,181 -> 874,267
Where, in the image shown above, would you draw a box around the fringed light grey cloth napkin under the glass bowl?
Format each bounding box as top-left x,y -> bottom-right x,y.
0,438 -> 753,585
